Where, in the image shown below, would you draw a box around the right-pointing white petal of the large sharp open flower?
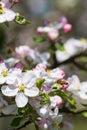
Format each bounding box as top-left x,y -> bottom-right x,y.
24,87 -> 39,97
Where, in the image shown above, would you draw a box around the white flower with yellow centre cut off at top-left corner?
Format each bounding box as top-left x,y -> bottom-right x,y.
0,2 -> 16,23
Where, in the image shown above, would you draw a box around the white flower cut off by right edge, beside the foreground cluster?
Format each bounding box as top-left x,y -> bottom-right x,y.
67,75 -> 87,111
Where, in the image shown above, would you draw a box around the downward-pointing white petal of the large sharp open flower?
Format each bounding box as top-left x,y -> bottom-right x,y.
15,92 -> 28,108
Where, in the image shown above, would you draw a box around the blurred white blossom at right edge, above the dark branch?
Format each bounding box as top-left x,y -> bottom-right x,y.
56,38 -> 87,62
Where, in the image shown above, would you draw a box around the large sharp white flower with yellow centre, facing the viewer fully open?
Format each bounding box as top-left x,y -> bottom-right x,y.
1,71 -> 39,107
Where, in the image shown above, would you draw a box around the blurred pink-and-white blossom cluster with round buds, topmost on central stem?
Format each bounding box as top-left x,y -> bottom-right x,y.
36,16 -> 72,41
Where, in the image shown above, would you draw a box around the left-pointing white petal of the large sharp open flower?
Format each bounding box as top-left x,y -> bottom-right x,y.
1,86 -> 18,97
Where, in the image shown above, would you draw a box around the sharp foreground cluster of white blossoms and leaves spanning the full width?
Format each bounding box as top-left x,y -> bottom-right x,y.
0,56 -> 87,130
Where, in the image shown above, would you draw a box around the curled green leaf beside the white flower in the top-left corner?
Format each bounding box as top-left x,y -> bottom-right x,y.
14,13 -> 31,25
